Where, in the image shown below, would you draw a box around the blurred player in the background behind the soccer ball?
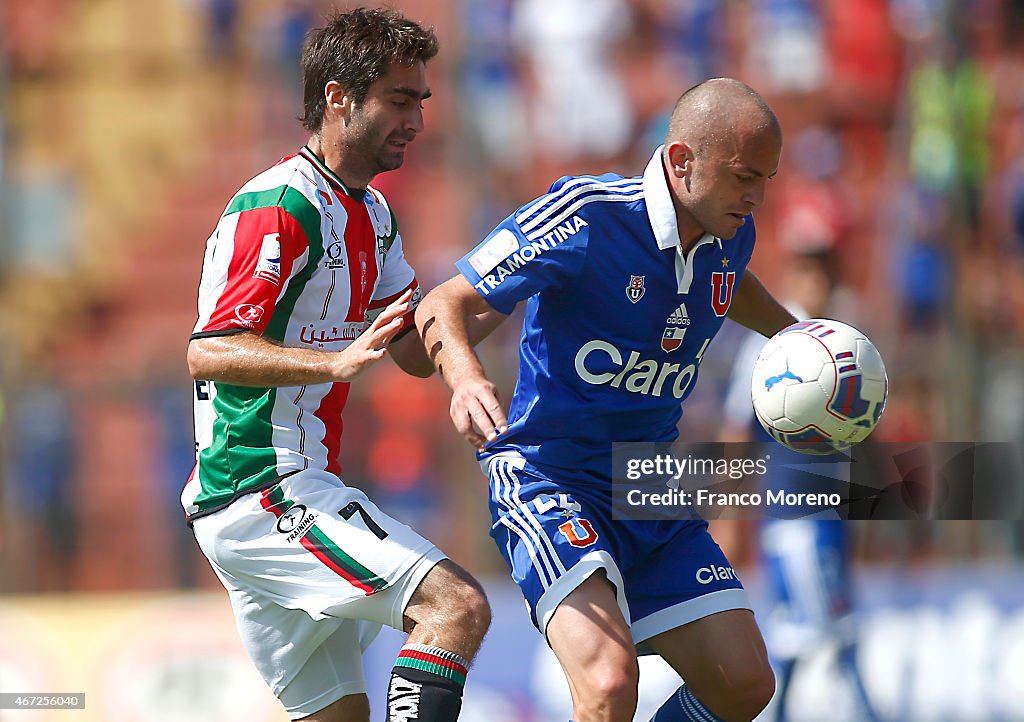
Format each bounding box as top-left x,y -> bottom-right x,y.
722,250 -> 880,722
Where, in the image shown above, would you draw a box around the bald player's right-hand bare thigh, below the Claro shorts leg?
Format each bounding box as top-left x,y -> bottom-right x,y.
646,609 -> 772,698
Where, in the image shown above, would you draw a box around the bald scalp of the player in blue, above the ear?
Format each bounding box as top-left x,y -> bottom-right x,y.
665,78 -> 782,154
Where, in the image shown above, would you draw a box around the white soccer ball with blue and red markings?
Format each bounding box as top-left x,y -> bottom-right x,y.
751,318 -> 889,455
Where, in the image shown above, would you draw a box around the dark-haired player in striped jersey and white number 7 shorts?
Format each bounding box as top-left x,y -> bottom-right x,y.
181,8 -> 490,722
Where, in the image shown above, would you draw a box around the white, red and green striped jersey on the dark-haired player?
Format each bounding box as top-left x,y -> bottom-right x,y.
181,147 -> 420,518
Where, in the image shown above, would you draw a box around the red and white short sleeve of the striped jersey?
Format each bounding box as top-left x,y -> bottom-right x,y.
193,206 -> 309,338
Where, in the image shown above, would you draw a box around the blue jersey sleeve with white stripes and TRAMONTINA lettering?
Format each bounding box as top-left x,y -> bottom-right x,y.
456,183 -> 590,314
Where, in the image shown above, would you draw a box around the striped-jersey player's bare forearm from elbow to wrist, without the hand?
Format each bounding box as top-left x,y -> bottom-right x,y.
188,332 -> 344,387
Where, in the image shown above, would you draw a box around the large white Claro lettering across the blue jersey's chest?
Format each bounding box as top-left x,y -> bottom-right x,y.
575,339 -> 711,398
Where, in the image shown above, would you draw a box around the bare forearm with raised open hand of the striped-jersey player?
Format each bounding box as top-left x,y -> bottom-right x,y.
188,292 -> 412,387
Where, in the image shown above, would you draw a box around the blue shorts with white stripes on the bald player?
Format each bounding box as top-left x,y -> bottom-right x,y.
483,452 -> 752,644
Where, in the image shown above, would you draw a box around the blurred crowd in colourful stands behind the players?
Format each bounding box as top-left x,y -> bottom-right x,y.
0,0 -> 1024,593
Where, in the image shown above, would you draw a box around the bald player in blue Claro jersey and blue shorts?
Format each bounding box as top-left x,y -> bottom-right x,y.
417,78 -> 795,722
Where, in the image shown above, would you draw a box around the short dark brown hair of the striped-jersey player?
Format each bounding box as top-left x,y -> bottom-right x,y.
302,7 -> 437,133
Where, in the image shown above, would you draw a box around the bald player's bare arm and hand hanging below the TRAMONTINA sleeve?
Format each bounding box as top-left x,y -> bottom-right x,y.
416,275 -> 508,449
